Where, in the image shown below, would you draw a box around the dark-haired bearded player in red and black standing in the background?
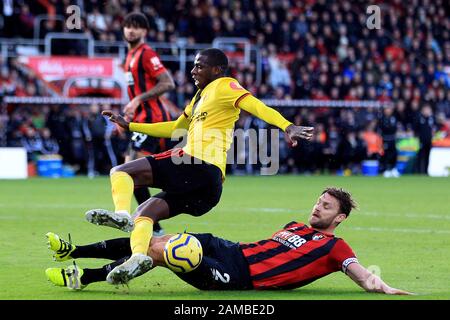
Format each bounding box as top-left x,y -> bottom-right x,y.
119,12 -> 175,236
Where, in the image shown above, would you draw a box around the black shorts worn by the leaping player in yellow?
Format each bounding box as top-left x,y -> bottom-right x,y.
146,148 -> 222,217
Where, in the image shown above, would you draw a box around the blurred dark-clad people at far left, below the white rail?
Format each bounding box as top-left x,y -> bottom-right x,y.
6,105 -> 126,176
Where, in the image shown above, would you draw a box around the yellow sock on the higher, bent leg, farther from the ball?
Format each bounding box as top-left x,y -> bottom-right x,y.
110,171 -> 134,213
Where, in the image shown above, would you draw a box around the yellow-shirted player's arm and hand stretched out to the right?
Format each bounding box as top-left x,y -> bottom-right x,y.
237,94 -> 314,147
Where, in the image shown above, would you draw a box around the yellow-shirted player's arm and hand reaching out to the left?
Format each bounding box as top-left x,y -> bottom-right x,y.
102,110 -> 189,138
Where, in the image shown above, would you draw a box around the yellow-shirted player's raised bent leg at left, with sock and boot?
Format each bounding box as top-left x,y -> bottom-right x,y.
86,158 -> 153,232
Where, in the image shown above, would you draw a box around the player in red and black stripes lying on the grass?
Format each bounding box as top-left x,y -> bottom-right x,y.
46,187 -> 411,295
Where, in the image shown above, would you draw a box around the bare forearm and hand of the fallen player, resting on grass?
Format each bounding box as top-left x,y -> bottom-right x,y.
347,263 -> 413,295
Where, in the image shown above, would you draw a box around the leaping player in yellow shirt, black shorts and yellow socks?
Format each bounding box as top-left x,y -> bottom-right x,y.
86,48 -> 313,284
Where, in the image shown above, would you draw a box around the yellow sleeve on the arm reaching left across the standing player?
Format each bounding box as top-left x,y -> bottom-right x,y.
129,113 -> 189,138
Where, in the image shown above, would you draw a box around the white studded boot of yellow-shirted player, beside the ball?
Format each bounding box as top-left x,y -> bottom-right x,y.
106,253 -> 153,285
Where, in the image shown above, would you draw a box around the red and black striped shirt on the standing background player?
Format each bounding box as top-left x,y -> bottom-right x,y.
125,43 -> 171,123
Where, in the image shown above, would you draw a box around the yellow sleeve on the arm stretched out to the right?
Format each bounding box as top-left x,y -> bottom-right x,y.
236,94 -> 292,131
